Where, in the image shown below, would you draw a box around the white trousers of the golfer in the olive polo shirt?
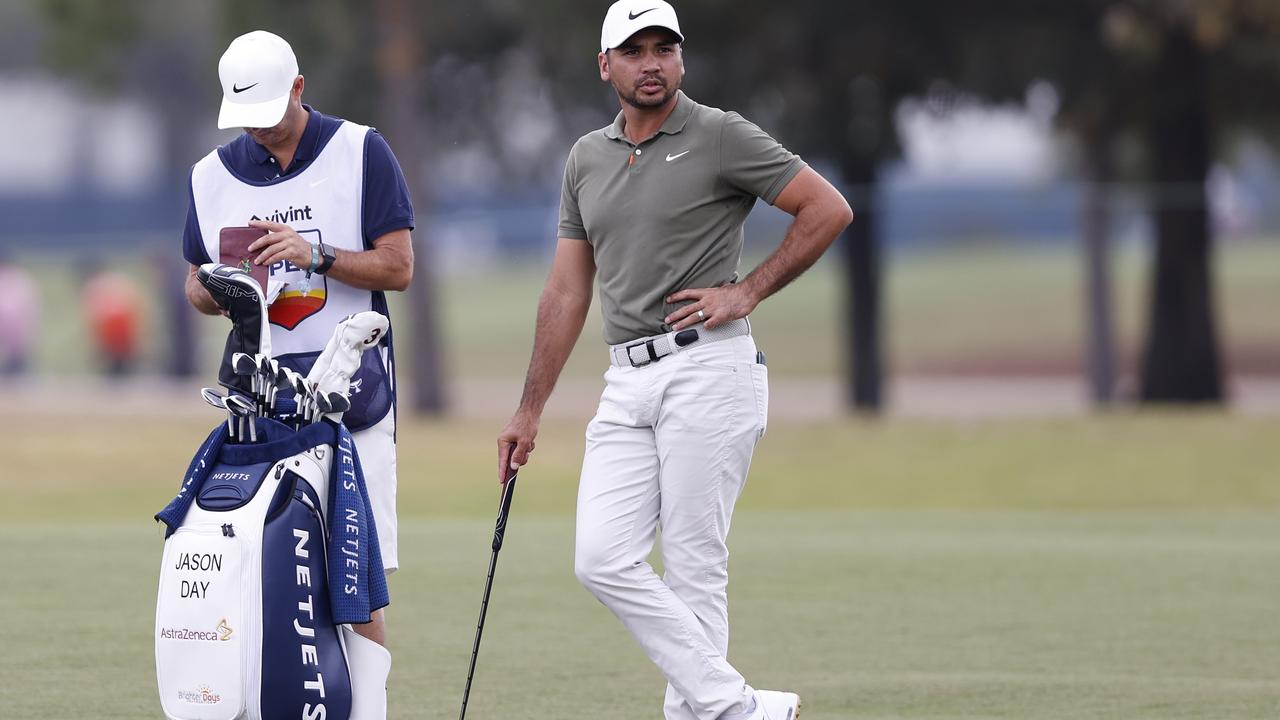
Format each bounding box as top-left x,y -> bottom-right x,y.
575,336 -> 769,720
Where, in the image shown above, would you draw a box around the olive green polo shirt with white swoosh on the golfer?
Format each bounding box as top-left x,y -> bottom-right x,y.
558,92 -> 806,345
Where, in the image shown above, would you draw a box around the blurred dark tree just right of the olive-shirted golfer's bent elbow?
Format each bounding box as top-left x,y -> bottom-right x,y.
681,0 -> 961,413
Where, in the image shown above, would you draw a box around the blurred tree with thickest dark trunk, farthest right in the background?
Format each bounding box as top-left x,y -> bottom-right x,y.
1103,0 -> 1280,402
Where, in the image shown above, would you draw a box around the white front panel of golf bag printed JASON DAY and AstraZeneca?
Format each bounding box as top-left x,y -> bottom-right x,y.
156,523 -> 252,720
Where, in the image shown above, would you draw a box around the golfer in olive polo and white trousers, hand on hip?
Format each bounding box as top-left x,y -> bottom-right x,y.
498,0 -> 852,720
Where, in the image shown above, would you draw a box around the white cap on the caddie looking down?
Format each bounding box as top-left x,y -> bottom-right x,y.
218,29 -> 298,128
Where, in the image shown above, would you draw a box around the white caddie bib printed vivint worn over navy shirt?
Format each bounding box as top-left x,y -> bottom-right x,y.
191,120 -> 372,356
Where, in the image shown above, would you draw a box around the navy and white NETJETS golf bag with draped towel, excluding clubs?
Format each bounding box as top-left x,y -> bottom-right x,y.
155,418 -> 388,720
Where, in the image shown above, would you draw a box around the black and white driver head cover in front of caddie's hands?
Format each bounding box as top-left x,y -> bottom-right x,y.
196,263 -> 271,395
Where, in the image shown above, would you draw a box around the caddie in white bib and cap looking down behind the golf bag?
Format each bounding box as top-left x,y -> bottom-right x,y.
183,31 -> 413,719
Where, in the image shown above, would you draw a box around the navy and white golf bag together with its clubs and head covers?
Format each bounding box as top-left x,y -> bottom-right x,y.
155,263 -> 390,720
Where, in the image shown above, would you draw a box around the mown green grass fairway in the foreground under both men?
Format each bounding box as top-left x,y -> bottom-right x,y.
0,409 -> 1280,720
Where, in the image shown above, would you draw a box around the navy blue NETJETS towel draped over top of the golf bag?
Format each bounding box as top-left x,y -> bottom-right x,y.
155,418 -> 390,624
